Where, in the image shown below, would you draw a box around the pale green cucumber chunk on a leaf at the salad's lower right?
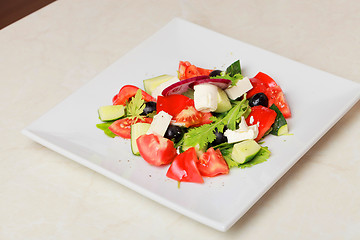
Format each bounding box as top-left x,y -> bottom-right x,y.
231,139 -> 261,164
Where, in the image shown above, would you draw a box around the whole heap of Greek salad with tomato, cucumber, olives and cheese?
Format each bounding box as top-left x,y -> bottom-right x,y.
97,61 -> 291,183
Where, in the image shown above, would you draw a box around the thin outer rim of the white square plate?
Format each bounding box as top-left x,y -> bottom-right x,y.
21,18 -> 360,232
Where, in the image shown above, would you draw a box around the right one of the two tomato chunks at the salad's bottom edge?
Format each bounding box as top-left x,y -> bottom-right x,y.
197,147 -> 229,177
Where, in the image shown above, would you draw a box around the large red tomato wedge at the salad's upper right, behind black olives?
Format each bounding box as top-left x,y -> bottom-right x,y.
246,72 -> 291,118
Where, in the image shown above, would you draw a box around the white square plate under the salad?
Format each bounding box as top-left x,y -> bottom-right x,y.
23,19 -> 360,231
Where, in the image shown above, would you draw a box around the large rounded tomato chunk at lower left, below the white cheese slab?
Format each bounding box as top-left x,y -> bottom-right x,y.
136,134 -> 177,166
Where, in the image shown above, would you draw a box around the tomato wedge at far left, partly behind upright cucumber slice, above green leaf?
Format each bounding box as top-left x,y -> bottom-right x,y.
109,118 -> 152,139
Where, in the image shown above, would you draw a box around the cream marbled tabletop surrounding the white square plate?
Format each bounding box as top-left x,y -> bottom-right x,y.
0,0 -> 360,240
